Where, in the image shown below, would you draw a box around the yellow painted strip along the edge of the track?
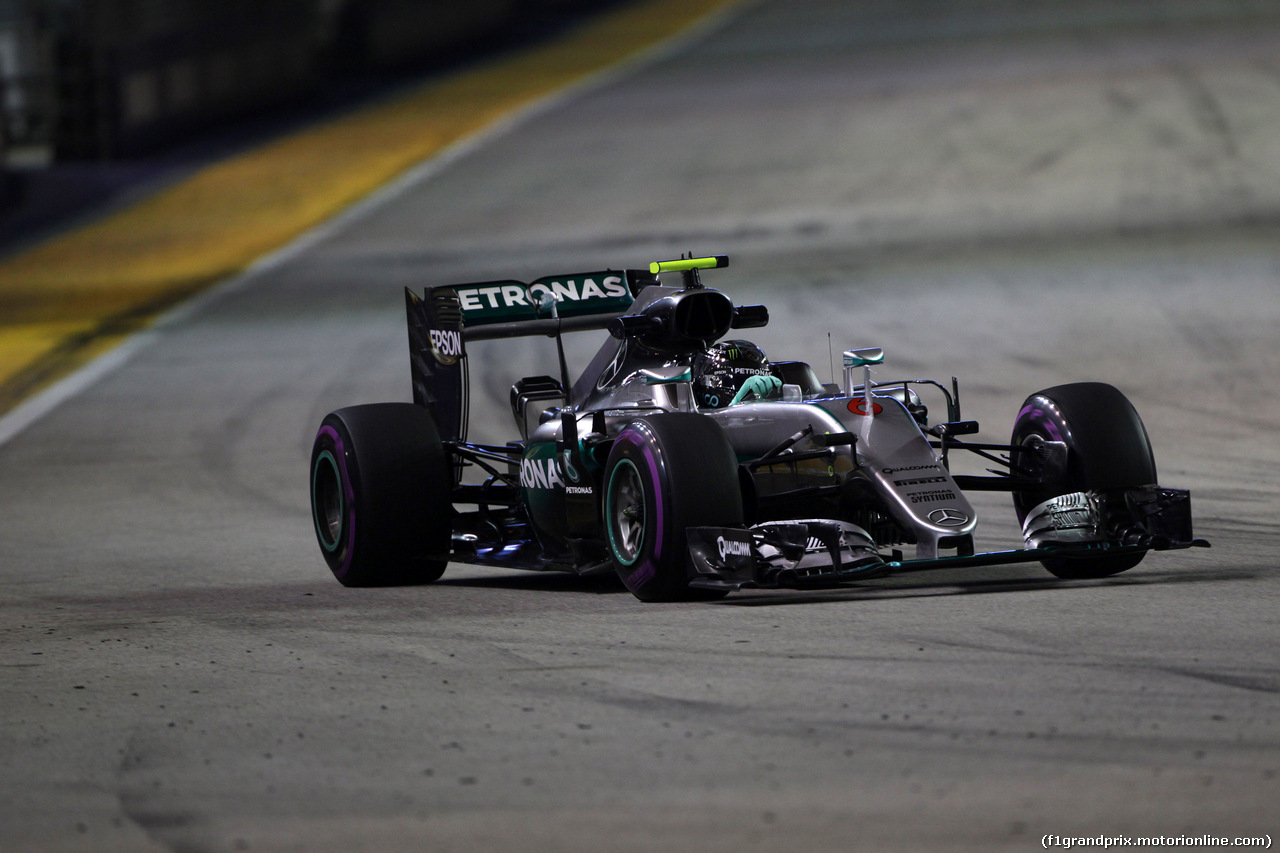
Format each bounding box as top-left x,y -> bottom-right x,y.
0,0 -> 742,411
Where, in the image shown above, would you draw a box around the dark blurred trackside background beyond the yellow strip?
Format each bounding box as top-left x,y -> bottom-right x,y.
0,0 -> 620,251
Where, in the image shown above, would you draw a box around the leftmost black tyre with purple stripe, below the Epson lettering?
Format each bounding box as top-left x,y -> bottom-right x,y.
311,403 -> 453,587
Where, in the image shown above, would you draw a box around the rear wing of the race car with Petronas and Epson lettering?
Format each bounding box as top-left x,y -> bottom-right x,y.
404,269 -> 658,441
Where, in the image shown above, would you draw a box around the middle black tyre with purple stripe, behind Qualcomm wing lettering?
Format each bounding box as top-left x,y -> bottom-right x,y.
602,412 -> 742,602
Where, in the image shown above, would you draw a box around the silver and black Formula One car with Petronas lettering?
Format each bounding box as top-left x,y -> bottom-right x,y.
311,256 -> 1208,601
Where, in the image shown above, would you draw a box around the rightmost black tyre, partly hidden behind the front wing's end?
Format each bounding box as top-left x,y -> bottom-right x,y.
1010,382 -> 1156,578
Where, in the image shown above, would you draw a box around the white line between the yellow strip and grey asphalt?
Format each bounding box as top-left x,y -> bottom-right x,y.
0,0 -> 759,447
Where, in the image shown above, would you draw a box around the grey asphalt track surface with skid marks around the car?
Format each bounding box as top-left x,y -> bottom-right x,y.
0,0 -> 1280,852
